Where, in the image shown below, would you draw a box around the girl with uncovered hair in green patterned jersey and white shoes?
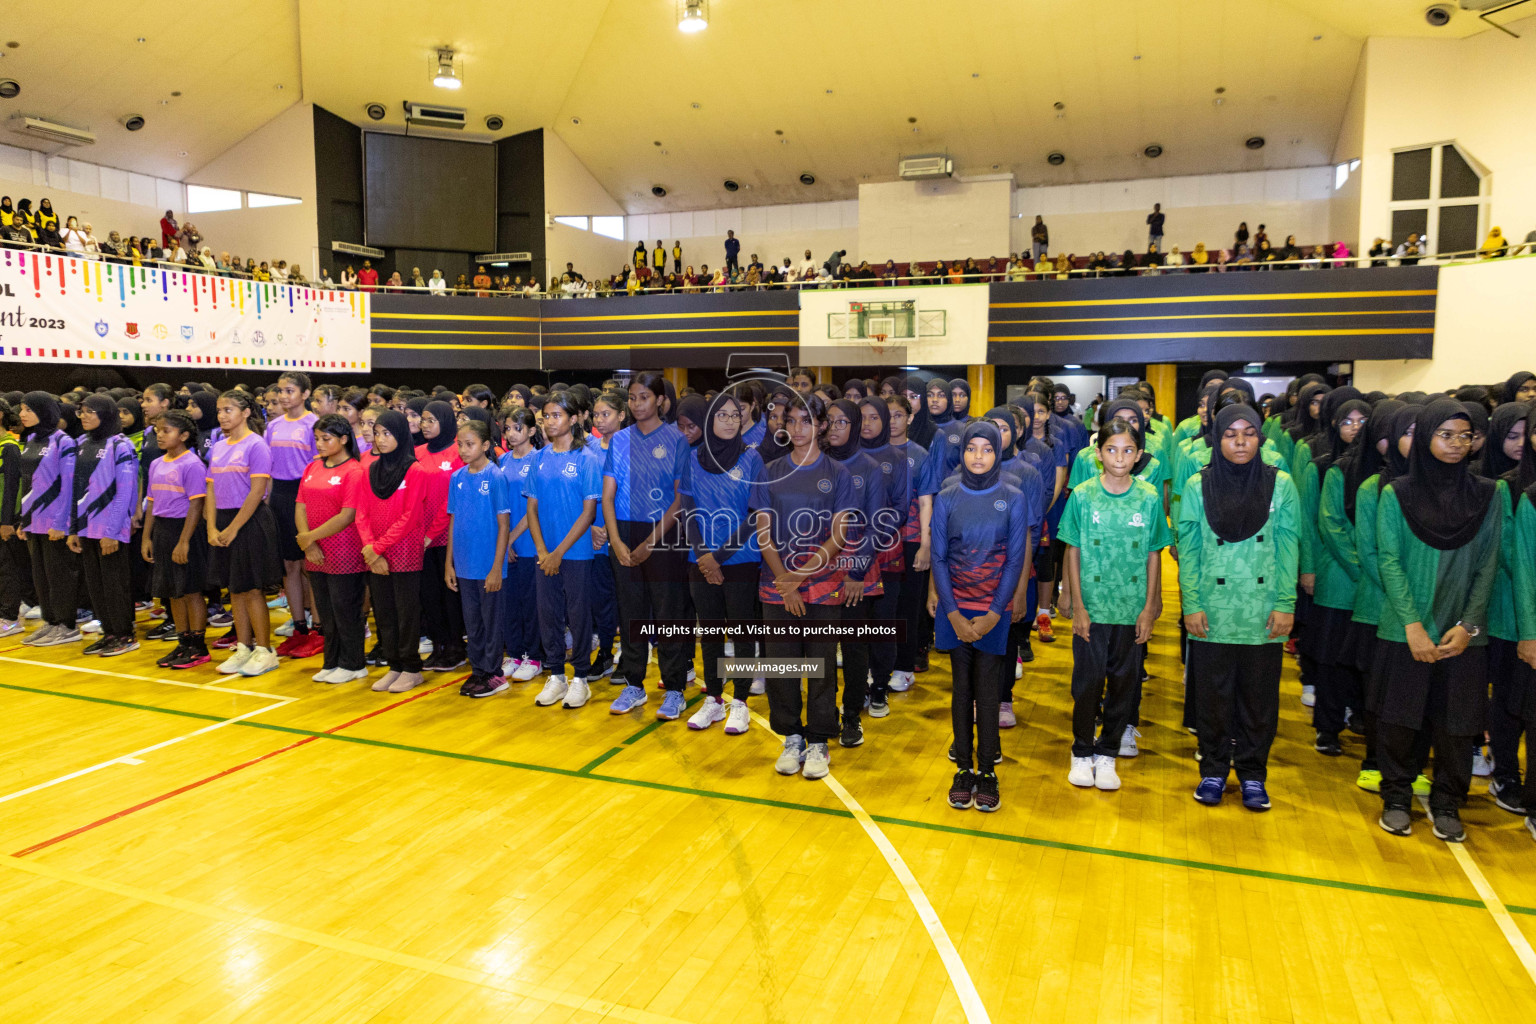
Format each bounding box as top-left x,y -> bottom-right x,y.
1057,417 -> 1174,789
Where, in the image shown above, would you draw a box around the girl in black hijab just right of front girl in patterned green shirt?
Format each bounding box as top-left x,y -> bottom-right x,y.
1293,387 -> 1370,757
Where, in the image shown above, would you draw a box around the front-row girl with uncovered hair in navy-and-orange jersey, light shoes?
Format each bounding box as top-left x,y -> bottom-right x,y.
756,395 -> 856,778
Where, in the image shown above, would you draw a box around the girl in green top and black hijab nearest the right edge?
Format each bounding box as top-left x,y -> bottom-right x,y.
1475,402 -> 1536,816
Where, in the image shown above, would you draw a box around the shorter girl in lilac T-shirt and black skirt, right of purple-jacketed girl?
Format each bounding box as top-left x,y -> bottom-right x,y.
141,410 -> 212,669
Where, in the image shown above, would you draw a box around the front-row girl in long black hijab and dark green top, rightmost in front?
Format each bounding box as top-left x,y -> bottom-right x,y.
1376,399 -> 1504,843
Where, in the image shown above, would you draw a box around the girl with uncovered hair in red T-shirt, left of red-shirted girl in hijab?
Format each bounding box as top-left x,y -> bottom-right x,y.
293,413 -> 369,683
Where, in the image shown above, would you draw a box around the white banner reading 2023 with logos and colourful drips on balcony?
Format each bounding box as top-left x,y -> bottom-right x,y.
0,249 -> 370,370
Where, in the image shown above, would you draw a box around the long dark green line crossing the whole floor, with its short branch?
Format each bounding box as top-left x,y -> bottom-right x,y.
9,683 -> 1536,917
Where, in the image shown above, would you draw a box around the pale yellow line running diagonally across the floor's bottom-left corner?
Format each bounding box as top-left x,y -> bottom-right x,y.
0,855 -> 684,1024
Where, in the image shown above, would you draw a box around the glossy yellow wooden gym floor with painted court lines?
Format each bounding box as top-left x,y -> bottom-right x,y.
0,563 -> 1536,1024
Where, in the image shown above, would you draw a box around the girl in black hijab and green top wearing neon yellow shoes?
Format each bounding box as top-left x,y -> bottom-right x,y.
1342,401 -> 1430,797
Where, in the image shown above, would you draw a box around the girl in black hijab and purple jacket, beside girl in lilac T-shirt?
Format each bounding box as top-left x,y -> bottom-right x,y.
68,395 -> 138,657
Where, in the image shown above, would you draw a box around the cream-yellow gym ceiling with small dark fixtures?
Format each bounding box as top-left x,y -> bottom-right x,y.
0,0 -> 1511,213
